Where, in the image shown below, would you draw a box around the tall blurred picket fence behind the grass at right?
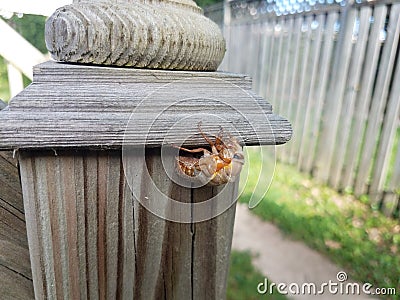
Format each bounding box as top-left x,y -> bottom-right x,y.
205,0 -> 400,216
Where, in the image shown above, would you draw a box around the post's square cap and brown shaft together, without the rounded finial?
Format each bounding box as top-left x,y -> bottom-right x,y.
0,62 -> 292,299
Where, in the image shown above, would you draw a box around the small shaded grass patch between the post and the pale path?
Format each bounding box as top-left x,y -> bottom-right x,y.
227,251 -> 287,300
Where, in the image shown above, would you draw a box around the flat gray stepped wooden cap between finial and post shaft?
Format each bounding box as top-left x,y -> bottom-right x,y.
0,62 -> 292,149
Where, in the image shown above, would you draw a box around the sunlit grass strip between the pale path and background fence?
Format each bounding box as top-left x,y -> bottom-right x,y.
240,151 -> 400,299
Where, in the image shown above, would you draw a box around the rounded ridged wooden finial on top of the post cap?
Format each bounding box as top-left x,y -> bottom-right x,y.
46,0 -> 225,71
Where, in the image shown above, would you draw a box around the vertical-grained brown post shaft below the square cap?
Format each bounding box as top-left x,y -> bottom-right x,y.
20,149 -> 237,299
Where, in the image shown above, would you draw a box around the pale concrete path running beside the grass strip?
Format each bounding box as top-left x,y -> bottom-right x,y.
233,204 -> 373,299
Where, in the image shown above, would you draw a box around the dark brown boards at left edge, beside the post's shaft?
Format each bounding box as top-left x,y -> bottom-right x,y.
0,152 -> 33,300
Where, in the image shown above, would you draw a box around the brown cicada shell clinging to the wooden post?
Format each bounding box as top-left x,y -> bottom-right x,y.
176,123 -> 244,185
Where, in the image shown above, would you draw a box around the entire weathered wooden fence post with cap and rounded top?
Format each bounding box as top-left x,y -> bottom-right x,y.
0,1 -> 291,299
